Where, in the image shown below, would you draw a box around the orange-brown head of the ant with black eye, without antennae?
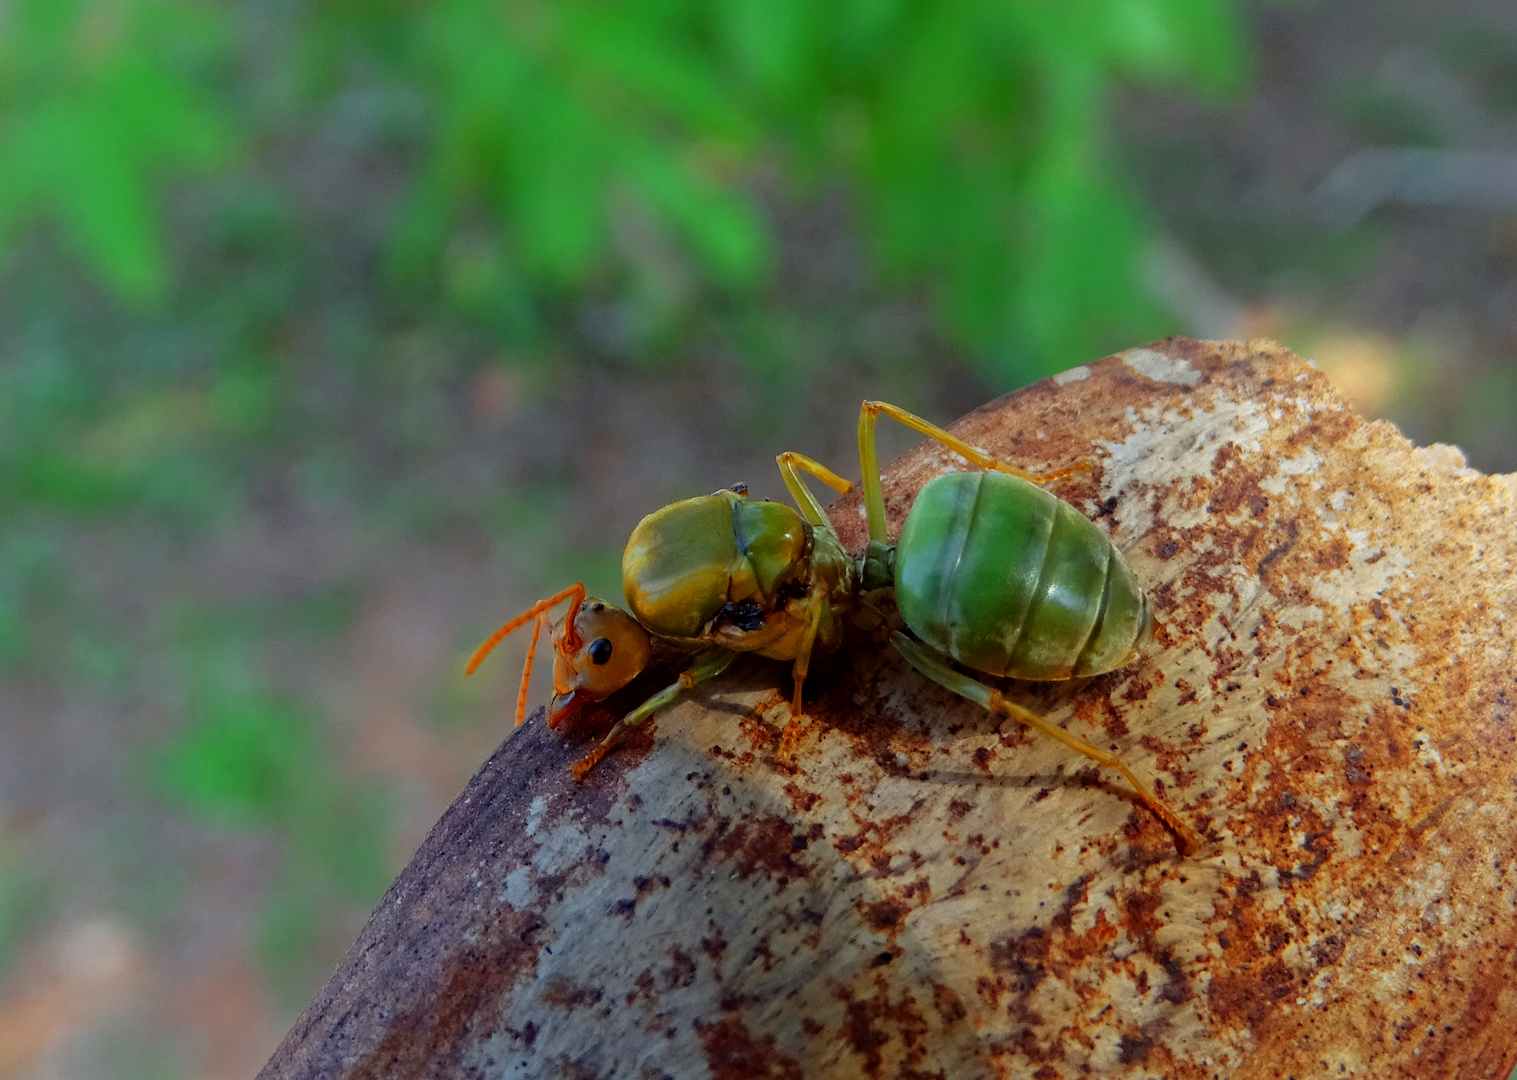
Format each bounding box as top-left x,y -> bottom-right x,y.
548,598 -> 652,728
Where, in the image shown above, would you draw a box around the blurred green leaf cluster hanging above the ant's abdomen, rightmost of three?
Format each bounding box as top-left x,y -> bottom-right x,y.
824,0 -> 1242,381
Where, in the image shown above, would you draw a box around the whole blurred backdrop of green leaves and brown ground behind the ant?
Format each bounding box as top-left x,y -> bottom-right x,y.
0,0 -> 1517,1080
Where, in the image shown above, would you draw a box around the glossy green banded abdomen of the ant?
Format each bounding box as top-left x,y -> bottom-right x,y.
895,473 -> 1148,680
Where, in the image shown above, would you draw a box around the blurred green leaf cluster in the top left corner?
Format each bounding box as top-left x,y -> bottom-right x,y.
0,0 -> 232,303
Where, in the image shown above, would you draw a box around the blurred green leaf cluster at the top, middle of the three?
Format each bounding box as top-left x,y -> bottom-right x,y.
399,0 -> 768,298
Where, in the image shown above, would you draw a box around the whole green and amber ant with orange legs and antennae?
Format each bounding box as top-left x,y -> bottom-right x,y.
467,402 -> 1201,851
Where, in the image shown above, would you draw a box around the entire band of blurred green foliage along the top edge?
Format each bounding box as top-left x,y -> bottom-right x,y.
0,0 -> 1245,383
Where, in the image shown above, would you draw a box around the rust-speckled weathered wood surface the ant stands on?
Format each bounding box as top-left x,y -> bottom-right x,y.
262,340 -> 1517,1080
